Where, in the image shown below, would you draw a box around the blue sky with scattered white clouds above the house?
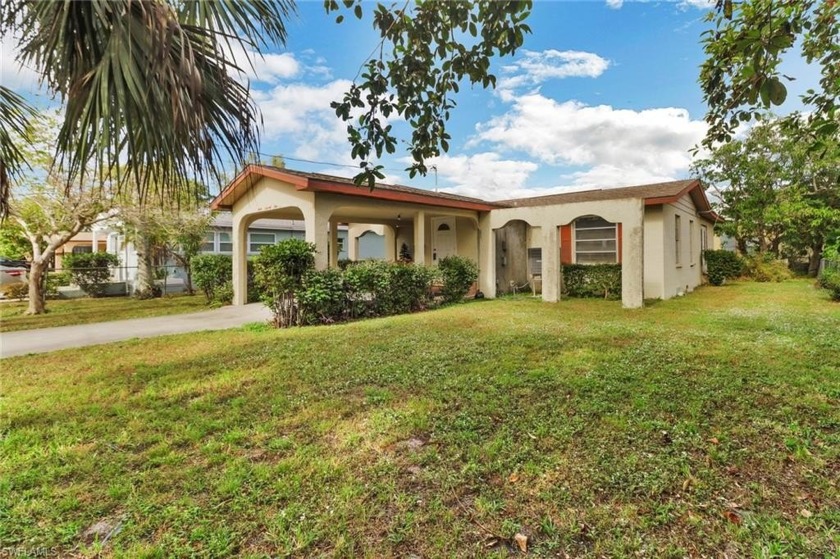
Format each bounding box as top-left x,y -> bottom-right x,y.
0,0 -> 815,199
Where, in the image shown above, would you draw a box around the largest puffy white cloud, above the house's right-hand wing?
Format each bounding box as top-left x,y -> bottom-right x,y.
476,93 -> 706,187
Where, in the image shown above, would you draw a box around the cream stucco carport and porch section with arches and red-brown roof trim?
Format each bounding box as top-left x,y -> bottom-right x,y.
212,165 -> 496,305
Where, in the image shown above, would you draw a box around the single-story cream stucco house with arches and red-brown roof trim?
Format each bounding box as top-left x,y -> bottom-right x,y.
211,165 -> 720,308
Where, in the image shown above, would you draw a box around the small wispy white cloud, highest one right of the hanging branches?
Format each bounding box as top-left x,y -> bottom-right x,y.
499,49 -> 610,90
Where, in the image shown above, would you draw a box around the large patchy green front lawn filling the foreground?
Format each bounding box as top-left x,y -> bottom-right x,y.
0,281 -> 840,558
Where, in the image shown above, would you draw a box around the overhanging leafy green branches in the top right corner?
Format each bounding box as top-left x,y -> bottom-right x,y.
700,0 -> 840,148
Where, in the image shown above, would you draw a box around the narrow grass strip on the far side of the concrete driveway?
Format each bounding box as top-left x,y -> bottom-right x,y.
0,295 -> 207,332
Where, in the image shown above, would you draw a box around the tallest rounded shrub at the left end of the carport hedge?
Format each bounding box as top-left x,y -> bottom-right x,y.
254,239 -> 315,328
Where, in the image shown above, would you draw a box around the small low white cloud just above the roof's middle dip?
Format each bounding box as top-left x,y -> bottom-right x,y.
426,152 -> 539,200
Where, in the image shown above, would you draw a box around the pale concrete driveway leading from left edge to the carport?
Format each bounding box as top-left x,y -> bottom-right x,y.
0,303 -> 271,358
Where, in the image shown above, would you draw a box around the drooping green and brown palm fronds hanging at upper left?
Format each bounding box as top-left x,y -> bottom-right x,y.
0,0 -> 295,215
